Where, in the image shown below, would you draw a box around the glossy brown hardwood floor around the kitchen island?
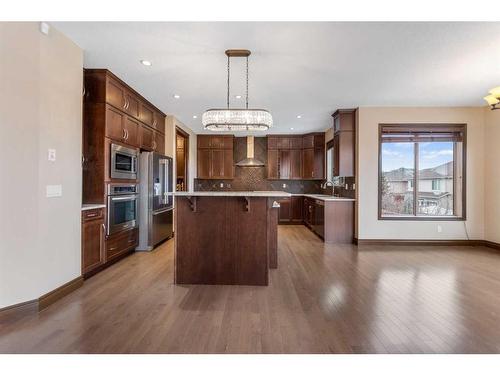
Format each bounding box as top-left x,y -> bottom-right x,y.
0,226 -> 500,353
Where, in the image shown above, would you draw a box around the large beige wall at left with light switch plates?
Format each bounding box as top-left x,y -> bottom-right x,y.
0,23 -> 83,308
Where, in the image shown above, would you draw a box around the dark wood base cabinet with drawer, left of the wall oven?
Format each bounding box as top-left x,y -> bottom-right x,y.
82,208 -> 105,276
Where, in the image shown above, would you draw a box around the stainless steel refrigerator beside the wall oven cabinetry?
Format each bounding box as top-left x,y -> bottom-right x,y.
136,152 -> 174,251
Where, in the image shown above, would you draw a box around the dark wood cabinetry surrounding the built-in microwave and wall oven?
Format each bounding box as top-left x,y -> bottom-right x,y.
82,69 -> 166,277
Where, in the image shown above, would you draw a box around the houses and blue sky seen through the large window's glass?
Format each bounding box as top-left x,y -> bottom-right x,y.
379,126 -> 462,217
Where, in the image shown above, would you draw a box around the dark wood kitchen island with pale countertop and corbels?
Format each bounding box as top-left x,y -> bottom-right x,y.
174,191 -> 290,285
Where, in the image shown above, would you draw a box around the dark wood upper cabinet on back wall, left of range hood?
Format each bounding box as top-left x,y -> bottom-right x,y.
197,135 -> 234,179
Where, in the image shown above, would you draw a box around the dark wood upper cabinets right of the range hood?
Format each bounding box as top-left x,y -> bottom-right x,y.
267,133 -> 325,180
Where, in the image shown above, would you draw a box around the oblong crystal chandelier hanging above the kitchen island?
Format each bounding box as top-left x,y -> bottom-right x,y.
201,49 -> 273,131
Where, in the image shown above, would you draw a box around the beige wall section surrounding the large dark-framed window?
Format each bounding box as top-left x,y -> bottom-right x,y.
357,107 -> 486,239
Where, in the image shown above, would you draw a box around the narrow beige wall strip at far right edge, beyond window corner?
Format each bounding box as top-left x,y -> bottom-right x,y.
484,108 -> 500,243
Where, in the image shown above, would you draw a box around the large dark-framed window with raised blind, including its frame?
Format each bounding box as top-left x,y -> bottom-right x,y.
379,124 -> 466,220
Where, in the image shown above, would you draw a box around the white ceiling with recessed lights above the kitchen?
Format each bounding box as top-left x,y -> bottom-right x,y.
53,22 -> 500,133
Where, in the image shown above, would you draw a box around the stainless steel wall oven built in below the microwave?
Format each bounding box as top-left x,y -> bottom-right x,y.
106,184 -> 139,235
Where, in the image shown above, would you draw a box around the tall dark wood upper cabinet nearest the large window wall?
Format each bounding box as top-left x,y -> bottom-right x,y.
332,109 -> 356,177
